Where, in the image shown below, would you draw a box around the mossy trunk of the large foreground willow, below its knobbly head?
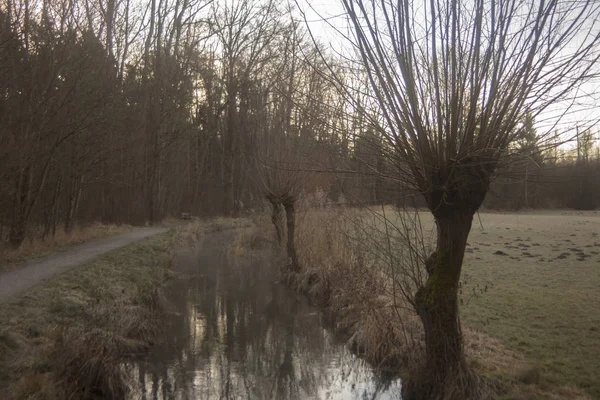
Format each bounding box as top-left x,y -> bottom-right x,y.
405,211 -> 474,400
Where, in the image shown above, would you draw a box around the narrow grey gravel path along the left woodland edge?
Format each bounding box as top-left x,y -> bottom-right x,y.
0,228 -> 167,303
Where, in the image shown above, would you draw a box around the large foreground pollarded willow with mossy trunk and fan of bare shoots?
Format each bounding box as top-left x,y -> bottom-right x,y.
342,0 -> 600,399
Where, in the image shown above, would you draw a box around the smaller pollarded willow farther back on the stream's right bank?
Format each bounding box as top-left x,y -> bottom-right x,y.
253,22 -> 333,272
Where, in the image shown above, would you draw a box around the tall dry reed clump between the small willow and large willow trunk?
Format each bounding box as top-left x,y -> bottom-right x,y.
293,207 -> 423,370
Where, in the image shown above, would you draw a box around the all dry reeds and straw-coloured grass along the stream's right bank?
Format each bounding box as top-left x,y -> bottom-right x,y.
230,207 -> 588,399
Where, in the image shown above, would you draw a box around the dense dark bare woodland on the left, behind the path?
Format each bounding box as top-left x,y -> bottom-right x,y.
0,0 -> 347,245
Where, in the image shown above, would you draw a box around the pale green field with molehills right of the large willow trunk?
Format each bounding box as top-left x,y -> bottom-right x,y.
461,212 -> 600,398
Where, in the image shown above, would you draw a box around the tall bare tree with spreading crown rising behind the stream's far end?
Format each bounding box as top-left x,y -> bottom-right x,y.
212,0 -> 283,215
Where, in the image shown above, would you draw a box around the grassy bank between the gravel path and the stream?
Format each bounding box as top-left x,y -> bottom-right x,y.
0,221 -> 206,399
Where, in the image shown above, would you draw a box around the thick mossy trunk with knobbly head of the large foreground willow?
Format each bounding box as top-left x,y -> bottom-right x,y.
405,158 -> 493,400
